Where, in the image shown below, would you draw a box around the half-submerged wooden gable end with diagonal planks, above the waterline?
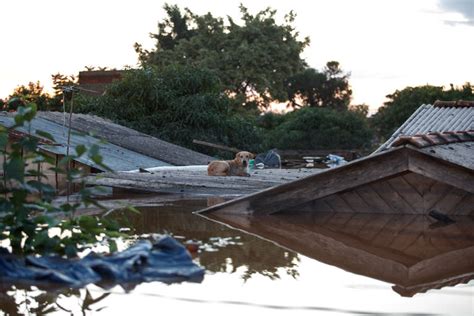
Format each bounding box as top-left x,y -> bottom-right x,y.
203,143 -> 474,215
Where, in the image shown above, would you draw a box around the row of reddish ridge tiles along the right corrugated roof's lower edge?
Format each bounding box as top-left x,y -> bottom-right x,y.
392,129 -> 474,148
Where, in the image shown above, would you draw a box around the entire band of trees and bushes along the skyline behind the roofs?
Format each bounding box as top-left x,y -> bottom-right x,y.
0,5 -> 474,154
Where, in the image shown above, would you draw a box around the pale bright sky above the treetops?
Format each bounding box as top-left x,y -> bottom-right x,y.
0,0 -> 474,112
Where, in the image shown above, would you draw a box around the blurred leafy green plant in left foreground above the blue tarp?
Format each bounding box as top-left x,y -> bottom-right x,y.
0,104 -> 130,257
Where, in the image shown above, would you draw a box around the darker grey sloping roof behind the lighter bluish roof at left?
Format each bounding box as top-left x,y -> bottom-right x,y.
37,112 -> 214,169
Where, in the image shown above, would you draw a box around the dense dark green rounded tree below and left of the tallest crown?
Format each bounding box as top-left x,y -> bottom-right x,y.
79,66 -> 260,153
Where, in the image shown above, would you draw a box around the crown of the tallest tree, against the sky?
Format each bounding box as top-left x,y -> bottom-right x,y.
136,5 -> 309,106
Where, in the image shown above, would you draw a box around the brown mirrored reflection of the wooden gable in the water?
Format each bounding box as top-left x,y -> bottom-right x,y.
206,212 -> 474,297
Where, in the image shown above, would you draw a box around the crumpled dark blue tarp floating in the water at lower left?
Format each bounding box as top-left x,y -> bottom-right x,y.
0,236 -> 204,288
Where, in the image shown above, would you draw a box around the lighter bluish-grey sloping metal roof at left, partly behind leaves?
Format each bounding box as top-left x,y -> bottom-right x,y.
0,113 -> 170,171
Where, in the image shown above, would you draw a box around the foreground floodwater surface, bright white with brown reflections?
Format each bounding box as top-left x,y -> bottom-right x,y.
0,199 -> 474,315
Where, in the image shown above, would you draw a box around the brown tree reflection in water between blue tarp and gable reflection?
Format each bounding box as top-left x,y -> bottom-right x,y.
109,200 -> 299,280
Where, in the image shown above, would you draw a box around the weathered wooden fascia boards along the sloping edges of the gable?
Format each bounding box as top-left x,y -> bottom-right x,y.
203,145 -> 474,215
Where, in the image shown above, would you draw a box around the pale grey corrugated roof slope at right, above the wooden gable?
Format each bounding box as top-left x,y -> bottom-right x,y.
374,104 -> 474,153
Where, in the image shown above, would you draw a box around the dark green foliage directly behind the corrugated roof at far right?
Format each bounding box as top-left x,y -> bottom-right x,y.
371,83 -> 474,139
